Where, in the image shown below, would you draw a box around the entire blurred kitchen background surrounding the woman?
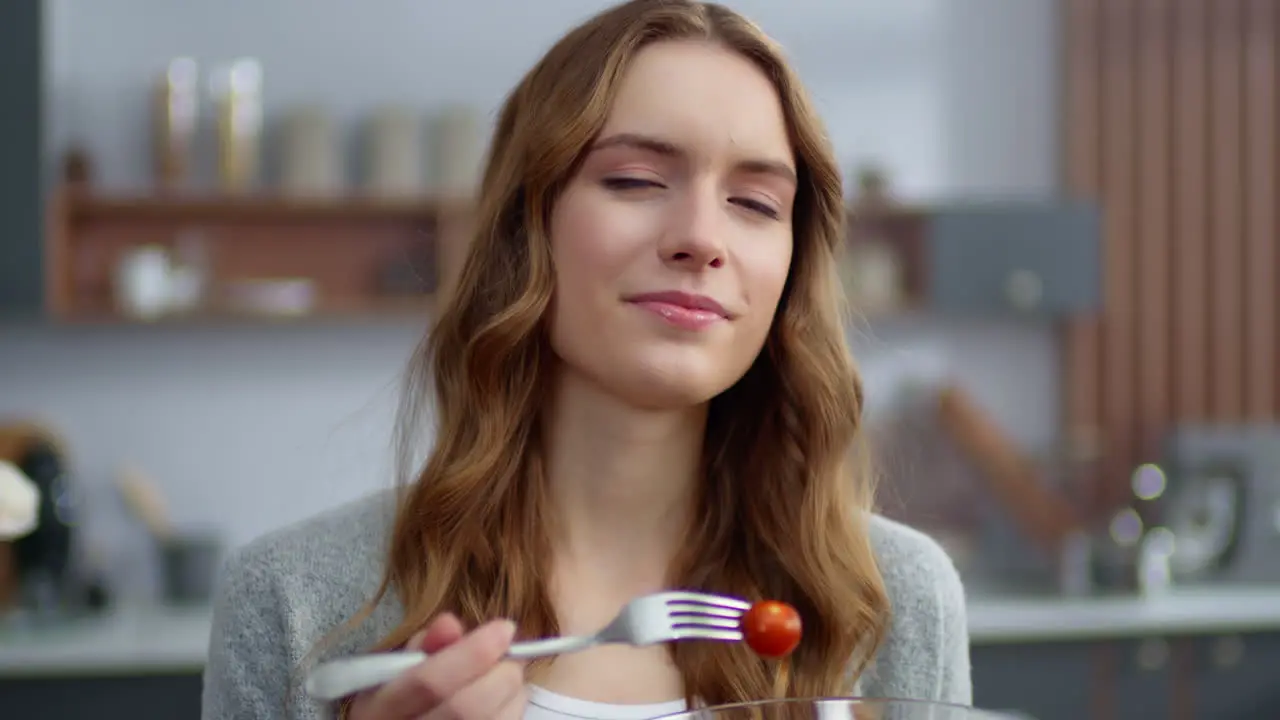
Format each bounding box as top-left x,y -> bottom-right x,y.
0,0 -> 1280,720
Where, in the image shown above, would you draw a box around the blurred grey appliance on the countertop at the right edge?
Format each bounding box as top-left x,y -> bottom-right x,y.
1152,424 -> 1280,583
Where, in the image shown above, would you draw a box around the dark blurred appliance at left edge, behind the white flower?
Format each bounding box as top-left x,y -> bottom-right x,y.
0,423 -> 78,610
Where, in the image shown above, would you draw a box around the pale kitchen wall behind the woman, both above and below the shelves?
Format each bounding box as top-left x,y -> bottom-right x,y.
0,0 -> 1059,584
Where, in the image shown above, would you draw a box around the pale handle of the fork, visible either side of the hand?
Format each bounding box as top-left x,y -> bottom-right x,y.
306,637 -> 598,702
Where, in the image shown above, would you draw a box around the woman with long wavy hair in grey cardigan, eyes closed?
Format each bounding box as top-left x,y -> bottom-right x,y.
205,0 -> 970,720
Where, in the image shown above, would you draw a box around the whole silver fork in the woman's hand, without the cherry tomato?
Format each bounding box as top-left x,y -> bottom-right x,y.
306,591 -> 751,701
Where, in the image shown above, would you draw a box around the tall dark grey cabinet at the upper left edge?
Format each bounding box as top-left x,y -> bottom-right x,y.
0,0 -> 44,318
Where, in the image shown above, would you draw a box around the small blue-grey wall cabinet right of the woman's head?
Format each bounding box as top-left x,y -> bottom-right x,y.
922,201 -> 1102,316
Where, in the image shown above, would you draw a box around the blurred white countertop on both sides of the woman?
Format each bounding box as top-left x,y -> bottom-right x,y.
0,587 -> 1280,678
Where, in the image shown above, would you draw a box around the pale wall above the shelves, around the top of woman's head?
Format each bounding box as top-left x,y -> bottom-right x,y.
46,0 -> 1056,196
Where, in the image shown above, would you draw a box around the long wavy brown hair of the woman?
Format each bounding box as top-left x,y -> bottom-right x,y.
350,0 -> 888,703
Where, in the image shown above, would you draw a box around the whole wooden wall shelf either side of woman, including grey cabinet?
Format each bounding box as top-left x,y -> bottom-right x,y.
44,186 -> 1101,324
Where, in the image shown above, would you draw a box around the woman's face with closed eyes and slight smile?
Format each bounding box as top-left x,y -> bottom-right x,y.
550,42 -> 796,409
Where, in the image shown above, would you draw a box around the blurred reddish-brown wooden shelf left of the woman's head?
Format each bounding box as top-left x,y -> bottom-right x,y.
45,186 -> 471,324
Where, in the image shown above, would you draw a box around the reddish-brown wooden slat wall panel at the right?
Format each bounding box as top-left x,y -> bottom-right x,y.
1062,0 -> 1280,510
